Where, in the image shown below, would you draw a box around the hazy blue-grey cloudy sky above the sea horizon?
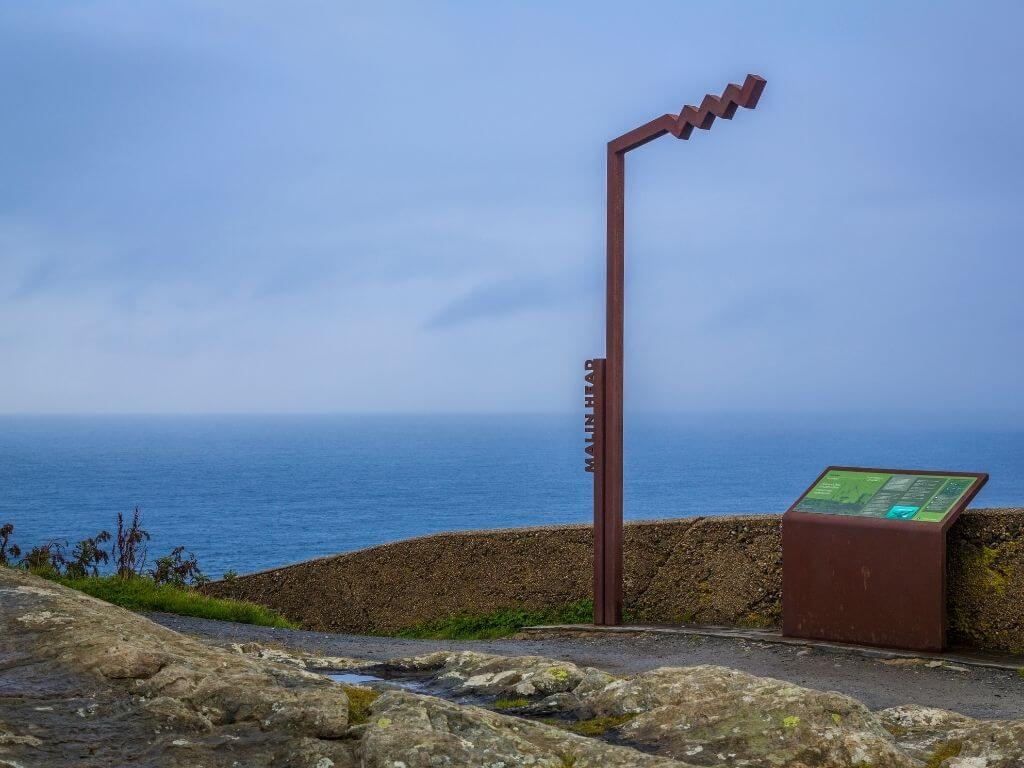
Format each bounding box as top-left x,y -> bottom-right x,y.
0,0 -> 1024,417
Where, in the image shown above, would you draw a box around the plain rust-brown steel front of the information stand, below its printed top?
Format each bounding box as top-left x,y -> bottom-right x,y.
782,510 -> 947,651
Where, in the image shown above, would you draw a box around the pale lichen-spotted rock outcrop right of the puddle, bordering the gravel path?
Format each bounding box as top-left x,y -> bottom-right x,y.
360,651 -> 1024,768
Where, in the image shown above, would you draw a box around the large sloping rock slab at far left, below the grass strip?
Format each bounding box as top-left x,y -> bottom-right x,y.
0,567 -> 352,768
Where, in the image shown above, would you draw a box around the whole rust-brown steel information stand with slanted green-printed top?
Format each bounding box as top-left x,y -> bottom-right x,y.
782,467 -> 988,651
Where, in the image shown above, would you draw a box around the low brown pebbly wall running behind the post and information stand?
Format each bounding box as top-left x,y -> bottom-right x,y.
206,509 -> 1024,652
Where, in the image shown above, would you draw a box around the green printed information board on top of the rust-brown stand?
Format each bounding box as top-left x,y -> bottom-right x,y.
794,469 -> 975,522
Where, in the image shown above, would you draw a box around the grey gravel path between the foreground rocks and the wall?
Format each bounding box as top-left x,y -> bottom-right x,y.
147,613 -> 1024,719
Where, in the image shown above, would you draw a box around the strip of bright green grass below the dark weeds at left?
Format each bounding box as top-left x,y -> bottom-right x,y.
45,572 -> 298,629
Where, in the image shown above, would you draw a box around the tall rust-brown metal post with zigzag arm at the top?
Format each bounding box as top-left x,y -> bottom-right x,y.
594,75 -> 765,625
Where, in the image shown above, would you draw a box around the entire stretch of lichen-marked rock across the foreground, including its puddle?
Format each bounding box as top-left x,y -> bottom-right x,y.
0,568 -> 1024,768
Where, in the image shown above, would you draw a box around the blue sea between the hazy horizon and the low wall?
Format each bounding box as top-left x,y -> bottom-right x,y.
0,415 -> 1024,575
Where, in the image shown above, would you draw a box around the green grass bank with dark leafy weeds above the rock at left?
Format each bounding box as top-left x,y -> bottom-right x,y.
0,507 -> 296,629
